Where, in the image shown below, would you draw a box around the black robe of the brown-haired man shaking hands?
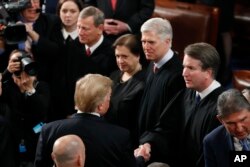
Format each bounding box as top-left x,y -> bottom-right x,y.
140,87 -> 224,167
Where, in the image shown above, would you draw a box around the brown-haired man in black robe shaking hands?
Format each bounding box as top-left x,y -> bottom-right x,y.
137,43 -> 223,167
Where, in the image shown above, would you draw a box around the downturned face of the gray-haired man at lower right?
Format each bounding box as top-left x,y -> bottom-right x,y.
218,109 -> 250,140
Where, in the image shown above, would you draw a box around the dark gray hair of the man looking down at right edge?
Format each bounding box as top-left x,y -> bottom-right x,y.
217,89 -> 250,118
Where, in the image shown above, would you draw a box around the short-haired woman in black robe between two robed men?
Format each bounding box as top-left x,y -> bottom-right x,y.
106,34 -> 145,147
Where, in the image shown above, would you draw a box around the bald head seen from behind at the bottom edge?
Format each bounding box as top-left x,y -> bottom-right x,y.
51,135 -> 85,167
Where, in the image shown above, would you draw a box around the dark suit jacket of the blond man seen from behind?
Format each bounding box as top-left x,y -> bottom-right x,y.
35,113 -> 144,167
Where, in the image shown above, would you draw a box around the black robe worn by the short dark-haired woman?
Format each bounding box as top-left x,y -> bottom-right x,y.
105,70 -> 146,147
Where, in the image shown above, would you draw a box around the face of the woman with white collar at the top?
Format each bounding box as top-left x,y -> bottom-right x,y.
60,1 -> 80,31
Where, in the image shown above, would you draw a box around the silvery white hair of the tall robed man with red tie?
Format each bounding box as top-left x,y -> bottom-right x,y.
141,17 -> 173,42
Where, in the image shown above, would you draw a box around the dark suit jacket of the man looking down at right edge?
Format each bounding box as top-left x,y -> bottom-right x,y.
203,125 -> 234,167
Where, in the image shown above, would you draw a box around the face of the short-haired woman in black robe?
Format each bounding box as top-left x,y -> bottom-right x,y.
115,45 -> 140,73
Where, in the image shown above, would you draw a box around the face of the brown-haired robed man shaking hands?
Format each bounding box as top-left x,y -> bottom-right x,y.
182,55 -> 212,92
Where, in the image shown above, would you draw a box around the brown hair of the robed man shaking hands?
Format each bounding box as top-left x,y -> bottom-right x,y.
184,42 -> 220,78
